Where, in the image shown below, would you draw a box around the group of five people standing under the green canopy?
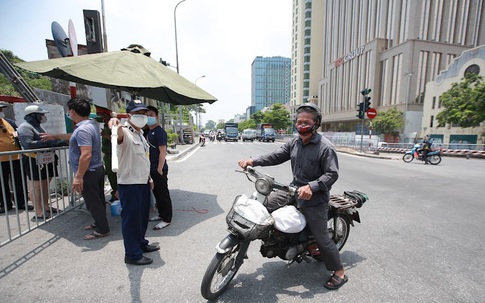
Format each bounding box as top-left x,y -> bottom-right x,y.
0,99 -> 172,265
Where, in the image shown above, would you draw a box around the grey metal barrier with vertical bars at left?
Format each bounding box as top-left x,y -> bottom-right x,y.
0,147 -> 84,247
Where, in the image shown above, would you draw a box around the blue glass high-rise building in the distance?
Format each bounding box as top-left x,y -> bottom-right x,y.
250,56 -> 291,114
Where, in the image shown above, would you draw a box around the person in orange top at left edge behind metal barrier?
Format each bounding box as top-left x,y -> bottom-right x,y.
0,101 -> 34,213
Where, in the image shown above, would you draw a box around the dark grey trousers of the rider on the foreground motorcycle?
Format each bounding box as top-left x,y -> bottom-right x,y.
265,190 -> 342,271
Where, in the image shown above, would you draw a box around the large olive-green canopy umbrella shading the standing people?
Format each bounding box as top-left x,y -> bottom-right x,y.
16,45 -> 217,105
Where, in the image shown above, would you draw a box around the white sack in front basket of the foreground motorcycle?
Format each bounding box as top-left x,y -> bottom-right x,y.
226,195 -> 274,239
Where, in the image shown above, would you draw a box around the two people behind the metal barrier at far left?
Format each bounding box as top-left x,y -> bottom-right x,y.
0,102 -> 67,221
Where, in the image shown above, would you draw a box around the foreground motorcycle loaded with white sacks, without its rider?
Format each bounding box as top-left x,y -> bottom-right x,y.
201,166 -> 368,300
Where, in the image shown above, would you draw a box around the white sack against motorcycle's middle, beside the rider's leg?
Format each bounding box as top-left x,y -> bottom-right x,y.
271,205 -> 306,234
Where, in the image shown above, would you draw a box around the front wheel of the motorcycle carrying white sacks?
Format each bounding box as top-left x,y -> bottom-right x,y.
200,245 -> 245,300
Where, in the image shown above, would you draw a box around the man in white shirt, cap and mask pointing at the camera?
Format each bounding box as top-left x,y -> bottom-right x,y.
108,100 -> 160,265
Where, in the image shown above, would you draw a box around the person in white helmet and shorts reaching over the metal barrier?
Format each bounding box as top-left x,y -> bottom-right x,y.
17,104 -> 68,221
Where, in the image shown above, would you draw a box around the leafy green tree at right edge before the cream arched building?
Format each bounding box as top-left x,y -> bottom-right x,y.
436,73 -> 485,127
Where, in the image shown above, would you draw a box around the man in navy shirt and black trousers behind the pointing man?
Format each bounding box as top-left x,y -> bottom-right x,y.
146,106 -> 172,230
